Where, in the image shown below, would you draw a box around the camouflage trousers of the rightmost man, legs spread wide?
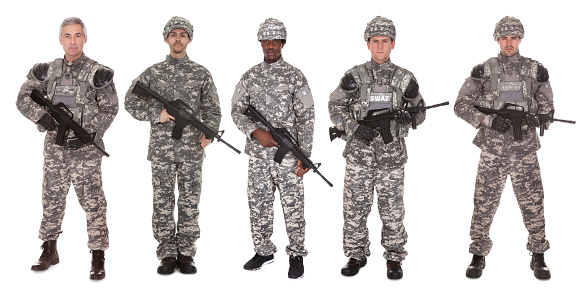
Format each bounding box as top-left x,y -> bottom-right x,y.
469,151 -> 550,256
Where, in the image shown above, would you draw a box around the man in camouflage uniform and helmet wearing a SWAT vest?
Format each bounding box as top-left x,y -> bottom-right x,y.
329,16 -> 425,279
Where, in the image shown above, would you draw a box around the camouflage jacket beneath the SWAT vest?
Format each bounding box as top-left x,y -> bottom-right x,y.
328,60 -> 426,168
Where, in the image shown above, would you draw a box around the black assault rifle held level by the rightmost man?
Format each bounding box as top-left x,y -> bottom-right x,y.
474,103 -> 576,141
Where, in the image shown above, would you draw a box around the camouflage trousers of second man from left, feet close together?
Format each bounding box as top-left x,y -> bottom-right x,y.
151,161 -> 202,260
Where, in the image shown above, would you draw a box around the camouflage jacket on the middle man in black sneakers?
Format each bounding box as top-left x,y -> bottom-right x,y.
231,58 -> 314,159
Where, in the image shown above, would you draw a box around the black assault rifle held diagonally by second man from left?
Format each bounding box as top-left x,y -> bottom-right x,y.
132,81 -> 241,154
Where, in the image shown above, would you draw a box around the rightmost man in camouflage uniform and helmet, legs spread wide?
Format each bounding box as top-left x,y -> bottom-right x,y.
454,16 -> 554,279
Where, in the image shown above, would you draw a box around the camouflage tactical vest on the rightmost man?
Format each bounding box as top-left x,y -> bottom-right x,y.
477,57 -> 538,113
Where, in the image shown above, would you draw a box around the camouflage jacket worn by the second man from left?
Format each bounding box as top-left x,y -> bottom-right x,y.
125,55 -> 221,162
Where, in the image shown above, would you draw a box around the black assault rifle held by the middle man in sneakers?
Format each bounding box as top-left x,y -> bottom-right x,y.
243,105 -> 333,187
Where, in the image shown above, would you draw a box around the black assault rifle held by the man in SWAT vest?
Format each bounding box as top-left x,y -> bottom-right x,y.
329,101 -> 450,144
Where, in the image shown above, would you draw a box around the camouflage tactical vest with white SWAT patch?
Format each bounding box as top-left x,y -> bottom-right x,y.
349,61 -> 413,137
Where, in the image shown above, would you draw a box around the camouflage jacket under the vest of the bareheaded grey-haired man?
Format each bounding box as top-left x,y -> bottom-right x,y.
16,54 -> 118,160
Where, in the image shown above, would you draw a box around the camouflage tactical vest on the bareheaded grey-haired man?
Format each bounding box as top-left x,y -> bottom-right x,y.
47,58 -> 99,128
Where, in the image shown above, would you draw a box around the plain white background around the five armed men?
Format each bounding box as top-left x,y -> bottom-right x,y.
0,0 -> 584,295
